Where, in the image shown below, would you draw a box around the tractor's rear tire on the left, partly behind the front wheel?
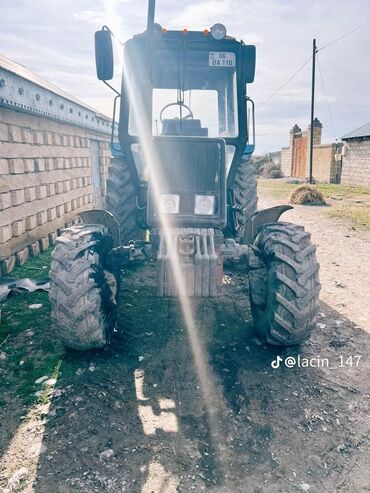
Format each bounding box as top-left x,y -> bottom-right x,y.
106,157 -> 144,244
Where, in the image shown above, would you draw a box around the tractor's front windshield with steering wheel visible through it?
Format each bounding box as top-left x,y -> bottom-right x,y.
129,46 -> 238,137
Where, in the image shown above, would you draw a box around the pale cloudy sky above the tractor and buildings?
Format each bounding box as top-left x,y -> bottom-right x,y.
0,0 -> 370,153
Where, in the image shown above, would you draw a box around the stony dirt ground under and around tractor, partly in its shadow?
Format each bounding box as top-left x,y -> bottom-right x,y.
0,182 -> 370,493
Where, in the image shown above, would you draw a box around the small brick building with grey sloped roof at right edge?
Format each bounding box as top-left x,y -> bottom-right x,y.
341,122 -> 370,188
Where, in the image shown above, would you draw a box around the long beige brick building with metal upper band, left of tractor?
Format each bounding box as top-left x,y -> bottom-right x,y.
0,56 -> 112,276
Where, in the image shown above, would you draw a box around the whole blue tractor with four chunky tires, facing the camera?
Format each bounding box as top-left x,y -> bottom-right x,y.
50,0 -> 320,350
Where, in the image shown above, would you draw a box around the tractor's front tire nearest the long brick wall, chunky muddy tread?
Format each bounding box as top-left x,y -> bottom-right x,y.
50,224 -> 117,350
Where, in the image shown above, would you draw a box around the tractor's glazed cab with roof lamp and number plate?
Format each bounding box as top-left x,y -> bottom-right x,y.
119,24 -> 255,179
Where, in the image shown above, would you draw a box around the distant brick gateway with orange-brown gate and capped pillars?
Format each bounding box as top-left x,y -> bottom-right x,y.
281,118 -> 341,183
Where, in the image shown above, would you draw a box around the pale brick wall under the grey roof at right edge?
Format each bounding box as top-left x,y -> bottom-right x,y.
341,138 -> 370,187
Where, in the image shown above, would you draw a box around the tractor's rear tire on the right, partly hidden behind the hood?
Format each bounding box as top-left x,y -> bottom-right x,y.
233,155 -> 258,239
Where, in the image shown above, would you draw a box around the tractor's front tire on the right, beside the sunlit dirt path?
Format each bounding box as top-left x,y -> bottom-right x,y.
249,222 -> 321,346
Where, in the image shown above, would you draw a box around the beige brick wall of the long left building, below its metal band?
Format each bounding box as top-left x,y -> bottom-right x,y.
0,107 -> 110,275
